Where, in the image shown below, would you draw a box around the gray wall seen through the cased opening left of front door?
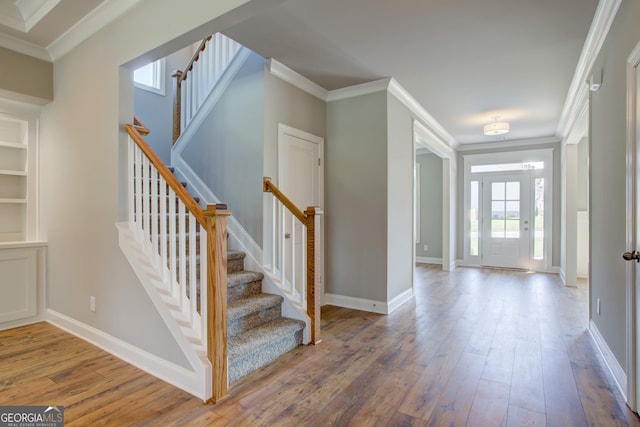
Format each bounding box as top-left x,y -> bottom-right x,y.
416,153 -> 443,258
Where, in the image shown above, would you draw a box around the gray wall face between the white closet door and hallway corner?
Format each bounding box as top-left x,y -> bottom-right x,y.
325,91 -> 387,301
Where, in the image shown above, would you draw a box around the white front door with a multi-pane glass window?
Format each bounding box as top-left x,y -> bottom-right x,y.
482,174 -> 531,269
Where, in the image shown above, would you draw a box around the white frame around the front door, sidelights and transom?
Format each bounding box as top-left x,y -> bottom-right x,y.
462,148 -> 553,272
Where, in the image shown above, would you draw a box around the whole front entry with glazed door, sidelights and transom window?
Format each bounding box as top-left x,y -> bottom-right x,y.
463,149 -> 553,271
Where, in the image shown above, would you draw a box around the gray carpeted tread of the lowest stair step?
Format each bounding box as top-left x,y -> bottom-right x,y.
228,317 -> 305,363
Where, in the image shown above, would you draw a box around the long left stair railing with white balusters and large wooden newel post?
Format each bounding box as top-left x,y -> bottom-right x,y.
126,124 -> 231,403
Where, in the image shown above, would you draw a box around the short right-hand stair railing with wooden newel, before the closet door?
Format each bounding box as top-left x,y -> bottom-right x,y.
262,177 -> 322,344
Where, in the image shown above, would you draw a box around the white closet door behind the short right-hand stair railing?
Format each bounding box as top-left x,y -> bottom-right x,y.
278,127 -> 322,302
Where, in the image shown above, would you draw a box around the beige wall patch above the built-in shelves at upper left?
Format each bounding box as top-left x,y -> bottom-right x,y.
0,47 -> 52,103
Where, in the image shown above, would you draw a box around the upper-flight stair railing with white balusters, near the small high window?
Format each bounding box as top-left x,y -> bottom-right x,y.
171,33 -> 242,144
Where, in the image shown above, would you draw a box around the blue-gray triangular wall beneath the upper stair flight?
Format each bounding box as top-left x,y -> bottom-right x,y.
182,53 -> 265,245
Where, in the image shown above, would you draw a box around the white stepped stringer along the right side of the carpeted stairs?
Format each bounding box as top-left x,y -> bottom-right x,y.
172,158 -> 311,344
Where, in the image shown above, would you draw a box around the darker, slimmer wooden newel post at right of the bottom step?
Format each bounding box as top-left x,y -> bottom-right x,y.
304,206 -> 322,344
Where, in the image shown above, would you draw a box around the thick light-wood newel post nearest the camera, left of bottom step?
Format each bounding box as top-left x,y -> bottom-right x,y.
203,204 -> 231,403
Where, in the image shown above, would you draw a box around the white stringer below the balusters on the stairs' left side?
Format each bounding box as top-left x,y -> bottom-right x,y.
116,222 -> 212,401
